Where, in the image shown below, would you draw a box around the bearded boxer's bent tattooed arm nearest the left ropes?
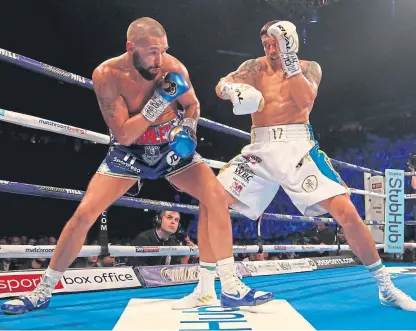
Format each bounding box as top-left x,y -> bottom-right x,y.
92,65 -> 151,146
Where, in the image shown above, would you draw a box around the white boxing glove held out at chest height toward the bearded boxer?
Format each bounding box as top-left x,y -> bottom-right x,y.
221,83 -> 264,115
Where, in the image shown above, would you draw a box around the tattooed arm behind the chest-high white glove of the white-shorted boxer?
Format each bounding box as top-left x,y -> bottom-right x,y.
215,59 -> 261,99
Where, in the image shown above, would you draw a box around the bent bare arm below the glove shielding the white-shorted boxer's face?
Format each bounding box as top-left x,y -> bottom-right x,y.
288,61 -> 322,110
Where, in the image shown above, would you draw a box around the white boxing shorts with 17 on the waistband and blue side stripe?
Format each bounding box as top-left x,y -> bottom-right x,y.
217,124 -> 349,220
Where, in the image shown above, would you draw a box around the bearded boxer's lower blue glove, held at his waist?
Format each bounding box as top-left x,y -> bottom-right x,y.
168,118 -> 197,159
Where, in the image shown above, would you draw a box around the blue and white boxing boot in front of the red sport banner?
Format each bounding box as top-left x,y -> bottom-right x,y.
1,275 -> 56,315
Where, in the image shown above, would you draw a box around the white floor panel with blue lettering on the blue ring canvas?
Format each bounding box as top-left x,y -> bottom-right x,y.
113,299 -> 315,331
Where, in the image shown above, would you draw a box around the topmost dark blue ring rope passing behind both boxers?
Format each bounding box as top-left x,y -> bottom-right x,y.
0,48 -> 386,176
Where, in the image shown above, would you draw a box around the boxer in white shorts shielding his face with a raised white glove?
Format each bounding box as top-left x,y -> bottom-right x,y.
174,21 -> 416,311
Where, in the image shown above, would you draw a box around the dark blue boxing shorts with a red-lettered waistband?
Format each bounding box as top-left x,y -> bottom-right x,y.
97,119 -> 203,181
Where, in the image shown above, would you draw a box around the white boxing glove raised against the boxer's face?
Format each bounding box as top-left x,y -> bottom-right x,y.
267,21 -> 299,54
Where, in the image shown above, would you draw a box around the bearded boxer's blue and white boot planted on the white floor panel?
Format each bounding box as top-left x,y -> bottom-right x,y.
217,257 -> 274,308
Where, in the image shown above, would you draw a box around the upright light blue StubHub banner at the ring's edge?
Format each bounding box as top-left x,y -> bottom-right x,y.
384,169 -> 404,253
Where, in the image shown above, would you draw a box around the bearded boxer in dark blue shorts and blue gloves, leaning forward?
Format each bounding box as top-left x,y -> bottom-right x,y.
1,17 -> 273,314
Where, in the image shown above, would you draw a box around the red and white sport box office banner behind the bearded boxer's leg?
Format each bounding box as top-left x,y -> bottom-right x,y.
0,267 -> 141,298
